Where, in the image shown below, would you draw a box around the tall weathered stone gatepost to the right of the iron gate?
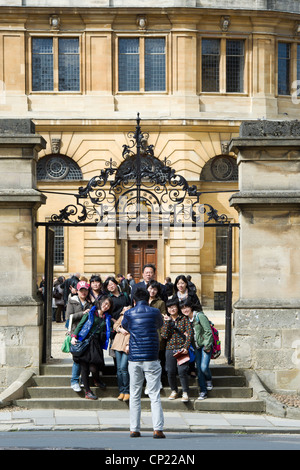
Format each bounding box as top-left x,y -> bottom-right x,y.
230,121 -> 300,393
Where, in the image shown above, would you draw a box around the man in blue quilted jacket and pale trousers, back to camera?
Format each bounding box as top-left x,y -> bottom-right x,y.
122,288 -> 165,439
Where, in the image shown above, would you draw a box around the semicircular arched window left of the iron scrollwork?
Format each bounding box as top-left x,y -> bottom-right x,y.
37,154 -> 83,181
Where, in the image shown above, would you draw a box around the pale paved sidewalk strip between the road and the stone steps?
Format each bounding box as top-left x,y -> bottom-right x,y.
0,409 -> 300,434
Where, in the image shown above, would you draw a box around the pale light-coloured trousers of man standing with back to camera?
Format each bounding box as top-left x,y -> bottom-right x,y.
128,360 -> 164,432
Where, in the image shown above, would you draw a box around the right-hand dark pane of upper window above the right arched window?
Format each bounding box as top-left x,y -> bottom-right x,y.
226,39 -> 244,93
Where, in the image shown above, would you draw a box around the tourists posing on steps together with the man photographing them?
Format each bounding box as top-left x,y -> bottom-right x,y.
48,264 -> 213,438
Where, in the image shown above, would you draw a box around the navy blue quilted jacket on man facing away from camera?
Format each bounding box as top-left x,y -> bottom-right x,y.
122,300 -> 163,362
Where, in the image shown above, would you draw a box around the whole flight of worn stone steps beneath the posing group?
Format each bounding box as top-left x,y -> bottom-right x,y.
15,360 -> 265,413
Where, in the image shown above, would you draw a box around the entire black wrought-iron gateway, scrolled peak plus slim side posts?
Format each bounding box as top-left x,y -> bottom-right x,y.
36,114 -> 239,363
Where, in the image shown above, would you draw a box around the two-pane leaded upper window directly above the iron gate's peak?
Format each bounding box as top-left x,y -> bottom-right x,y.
118,38 -> 166,92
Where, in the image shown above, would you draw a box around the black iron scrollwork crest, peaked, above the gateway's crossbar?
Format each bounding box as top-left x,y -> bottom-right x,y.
51,115 -> 229,231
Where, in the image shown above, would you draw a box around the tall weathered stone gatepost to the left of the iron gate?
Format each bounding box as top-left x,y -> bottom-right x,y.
0,119 -> 46,388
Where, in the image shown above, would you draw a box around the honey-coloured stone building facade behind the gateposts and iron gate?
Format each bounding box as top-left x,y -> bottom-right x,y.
0,0 -> 300,388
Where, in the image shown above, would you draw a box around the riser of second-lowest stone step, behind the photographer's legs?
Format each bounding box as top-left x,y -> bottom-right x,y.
26,387 -> 252,399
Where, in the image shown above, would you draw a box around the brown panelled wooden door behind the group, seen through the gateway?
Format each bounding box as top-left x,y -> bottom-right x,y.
128,240 -> 157,282
